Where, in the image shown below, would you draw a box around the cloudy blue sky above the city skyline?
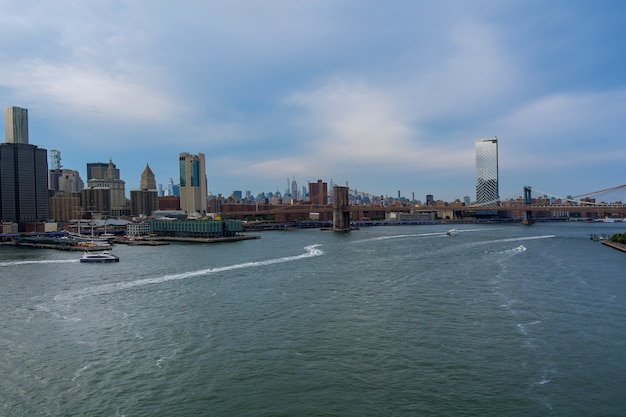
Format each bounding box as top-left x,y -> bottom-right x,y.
0,0 -> 626,201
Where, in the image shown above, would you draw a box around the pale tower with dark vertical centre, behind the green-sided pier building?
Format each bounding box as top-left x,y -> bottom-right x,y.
178,152 -> 208,215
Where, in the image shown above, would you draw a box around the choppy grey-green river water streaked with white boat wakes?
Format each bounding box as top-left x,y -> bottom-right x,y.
0,223 -> 626,416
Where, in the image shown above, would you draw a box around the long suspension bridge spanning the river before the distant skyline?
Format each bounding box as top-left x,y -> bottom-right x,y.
216,185 -> 626,223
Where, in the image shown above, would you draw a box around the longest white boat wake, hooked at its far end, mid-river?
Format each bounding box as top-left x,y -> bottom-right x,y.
54,245 -> 324,301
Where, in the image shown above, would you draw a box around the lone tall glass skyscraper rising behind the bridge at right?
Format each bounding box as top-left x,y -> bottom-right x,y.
475,136 -> 500,204
